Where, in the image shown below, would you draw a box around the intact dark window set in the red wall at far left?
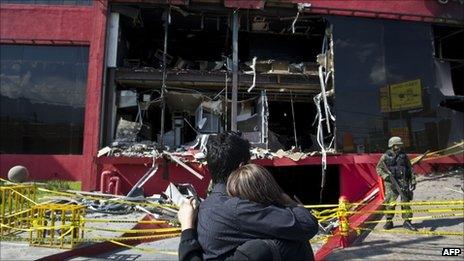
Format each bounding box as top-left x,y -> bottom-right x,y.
0,44 -> 89,154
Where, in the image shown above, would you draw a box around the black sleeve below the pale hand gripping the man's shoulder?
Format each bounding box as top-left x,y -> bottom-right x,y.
179,228 -> 203,261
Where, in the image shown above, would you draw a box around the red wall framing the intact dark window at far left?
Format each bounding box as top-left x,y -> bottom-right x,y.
0,0 -> 107,189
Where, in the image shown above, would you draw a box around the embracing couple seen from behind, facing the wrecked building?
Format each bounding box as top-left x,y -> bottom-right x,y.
178,132 -> 318,261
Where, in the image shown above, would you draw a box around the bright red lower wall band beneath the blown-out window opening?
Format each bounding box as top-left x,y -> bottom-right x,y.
96,154 -> 464,202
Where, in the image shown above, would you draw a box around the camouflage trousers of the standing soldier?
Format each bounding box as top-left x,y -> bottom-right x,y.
384,182 -> 413,220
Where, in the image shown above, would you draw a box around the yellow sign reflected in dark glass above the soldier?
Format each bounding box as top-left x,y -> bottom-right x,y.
390,79 -> 422,111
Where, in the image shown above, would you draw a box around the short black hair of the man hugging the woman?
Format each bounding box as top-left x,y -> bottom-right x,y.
206,132 -> 251,184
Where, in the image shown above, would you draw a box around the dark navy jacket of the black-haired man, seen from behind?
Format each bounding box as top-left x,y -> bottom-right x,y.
197,184 -> 318,260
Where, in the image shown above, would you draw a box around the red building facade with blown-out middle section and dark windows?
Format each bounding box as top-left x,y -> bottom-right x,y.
0,0 -> 464,203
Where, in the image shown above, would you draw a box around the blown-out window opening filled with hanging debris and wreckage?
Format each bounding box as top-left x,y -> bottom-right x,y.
105,5 -> 334,154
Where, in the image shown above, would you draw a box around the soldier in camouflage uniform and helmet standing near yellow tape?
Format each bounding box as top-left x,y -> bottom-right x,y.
376,137 -> 417,231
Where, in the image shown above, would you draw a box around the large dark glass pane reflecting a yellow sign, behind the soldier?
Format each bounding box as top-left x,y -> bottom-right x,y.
330,17 -> 464,153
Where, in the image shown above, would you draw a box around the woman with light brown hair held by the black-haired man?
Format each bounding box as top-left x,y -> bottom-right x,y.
179,164 -> 314,261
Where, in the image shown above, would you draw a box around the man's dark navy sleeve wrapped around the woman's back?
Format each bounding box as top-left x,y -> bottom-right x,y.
235,200 -> 319,241
